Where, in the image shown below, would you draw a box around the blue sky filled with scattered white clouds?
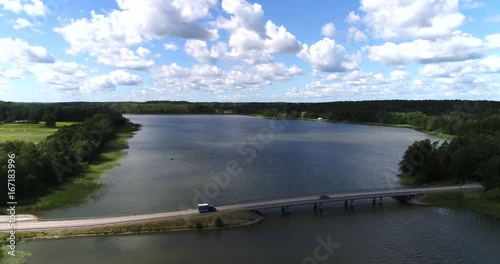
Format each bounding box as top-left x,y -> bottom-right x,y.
0,0 -> 500,102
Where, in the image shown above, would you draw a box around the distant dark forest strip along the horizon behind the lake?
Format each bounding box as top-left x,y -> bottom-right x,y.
0,100 -> 500,135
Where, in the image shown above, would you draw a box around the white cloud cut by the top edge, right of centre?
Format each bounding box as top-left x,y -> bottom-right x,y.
360,0 -> 465,40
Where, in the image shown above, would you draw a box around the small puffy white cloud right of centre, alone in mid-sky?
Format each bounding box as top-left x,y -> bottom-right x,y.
298,37 -> 361,72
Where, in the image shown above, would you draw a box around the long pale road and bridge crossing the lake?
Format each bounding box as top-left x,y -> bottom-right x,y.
0,184 -> 484,232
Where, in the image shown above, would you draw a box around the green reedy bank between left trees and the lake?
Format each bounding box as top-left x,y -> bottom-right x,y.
17,124 -> 138,215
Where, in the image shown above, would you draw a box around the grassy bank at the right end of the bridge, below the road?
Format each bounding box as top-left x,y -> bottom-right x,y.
423,191 -> 500,219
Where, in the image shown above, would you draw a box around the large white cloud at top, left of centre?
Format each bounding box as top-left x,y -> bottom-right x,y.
54,0 -> 218,69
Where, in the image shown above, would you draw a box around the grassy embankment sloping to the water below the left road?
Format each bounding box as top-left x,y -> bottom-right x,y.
0,211 -> 264,242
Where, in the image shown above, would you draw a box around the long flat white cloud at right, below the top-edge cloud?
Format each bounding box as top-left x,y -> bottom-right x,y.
367,31 -> 486,65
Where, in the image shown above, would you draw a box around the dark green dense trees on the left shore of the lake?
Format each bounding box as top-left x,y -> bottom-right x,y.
0,105 -> 126,204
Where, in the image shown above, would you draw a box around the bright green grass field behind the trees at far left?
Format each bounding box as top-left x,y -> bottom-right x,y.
0,122 -> 77,143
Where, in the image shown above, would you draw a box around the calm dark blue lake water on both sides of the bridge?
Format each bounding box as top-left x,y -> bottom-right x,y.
20,116 -> 500,263
